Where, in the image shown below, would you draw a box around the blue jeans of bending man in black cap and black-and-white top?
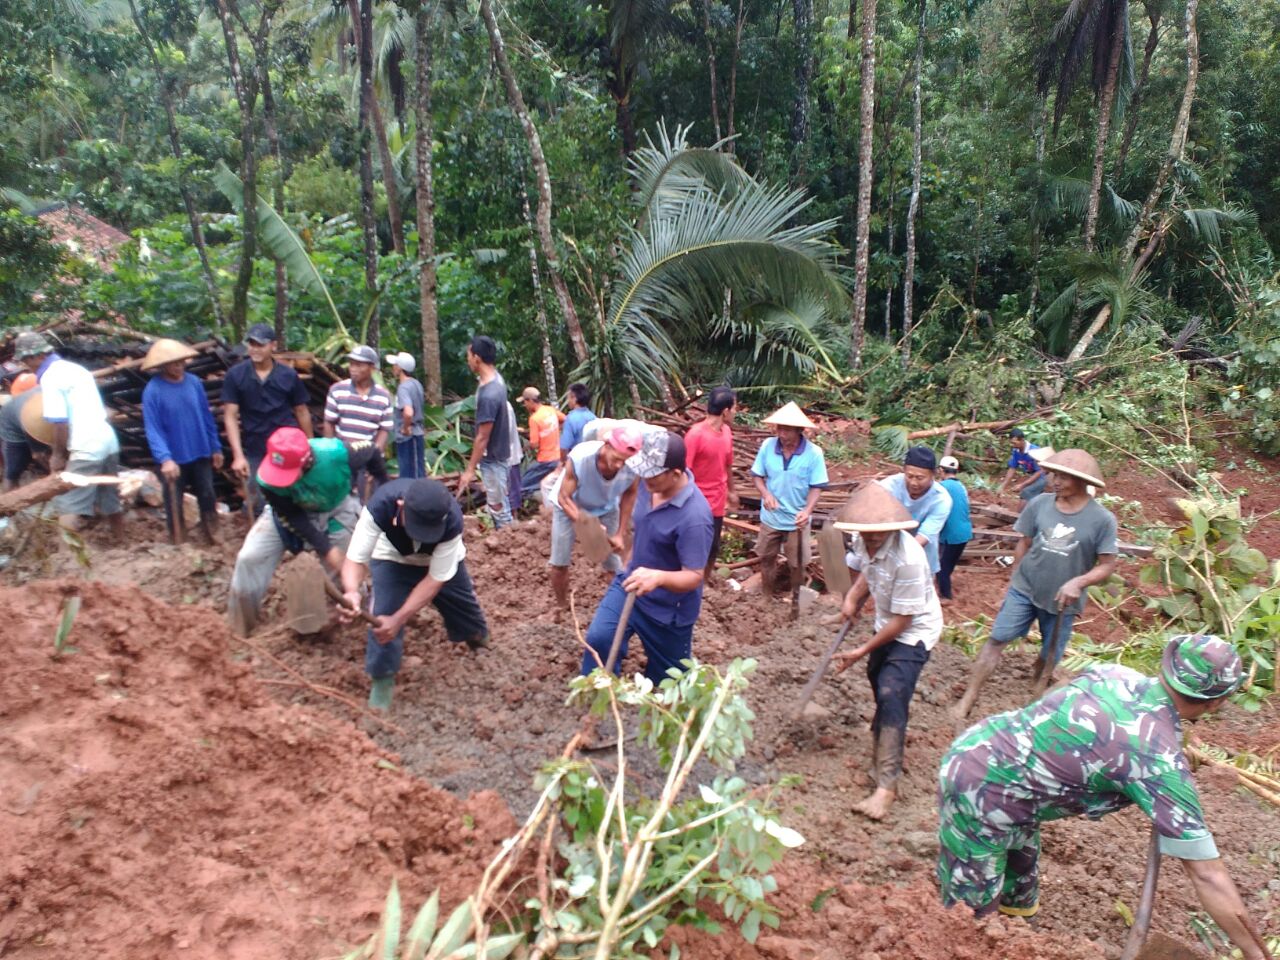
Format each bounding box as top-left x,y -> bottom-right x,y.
365,561 -> 489,677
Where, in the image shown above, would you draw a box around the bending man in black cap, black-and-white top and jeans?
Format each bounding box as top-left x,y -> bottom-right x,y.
342,479 -> 489,710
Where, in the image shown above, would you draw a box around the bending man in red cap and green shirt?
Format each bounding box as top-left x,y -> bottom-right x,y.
227,426 -> 388,636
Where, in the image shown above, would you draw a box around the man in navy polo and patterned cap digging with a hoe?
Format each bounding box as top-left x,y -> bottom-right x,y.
582,430 -> 714,684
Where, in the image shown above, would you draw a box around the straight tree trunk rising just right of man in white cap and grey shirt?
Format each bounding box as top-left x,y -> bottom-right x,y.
413,3 -> 444,407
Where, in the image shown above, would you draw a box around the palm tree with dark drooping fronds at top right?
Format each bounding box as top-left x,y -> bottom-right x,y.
1039,0 -> 1133,252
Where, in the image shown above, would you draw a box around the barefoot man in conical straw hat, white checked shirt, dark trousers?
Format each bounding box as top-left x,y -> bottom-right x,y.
835,484 -> 942,820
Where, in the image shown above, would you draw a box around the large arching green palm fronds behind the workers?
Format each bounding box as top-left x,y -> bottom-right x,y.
573,127 -> 847,407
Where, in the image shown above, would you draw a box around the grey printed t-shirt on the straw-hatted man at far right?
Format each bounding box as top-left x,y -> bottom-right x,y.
1009,493 -> 1116,613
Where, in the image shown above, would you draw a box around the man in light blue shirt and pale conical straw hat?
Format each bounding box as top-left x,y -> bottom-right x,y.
751,402 -> 827,617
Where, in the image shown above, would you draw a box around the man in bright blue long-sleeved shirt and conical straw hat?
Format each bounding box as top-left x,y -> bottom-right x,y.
142,339 -> 223,543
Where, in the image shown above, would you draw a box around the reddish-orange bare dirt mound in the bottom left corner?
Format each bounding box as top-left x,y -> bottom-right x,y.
0,581 -> 515,960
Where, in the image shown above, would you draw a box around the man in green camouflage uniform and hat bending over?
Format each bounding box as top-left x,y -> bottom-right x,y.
938,635 -> 1266,960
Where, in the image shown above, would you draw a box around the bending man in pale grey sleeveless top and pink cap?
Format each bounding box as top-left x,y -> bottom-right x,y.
550,421 -> 643,618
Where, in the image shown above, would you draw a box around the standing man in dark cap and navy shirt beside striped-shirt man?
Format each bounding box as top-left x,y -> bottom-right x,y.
223,324 -> 315,516
